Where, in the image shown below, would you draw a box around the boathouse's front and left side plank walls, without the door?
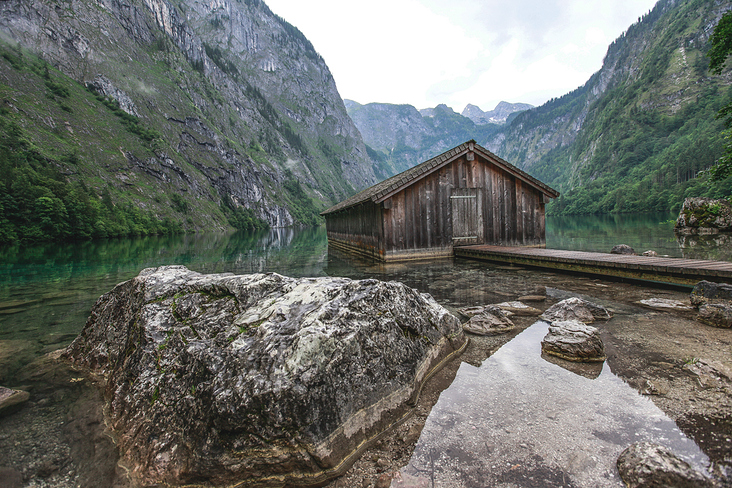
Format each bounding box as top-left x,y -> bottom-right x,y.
326,154 -> 545,261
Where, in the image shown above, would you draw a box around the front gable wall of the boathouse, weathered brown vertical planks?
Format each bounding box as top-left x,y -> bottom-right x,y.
382,155 -> 545,259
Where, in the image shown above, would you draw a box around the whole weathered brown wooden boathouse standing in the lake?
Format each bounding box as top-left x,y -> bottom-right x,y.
321,140 -> 559,261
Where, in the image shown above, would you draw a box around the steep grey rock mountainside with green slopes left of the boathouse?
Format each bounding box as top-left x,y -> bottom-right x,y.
0,0 -> 376,242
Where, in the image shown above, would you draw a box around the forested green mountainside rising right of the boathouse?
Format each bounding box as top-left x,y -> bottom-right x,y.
478,0 -> 732,214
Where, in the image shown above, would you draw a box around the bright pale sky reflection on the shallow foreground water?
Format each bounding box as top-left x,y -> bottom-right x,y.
392,322 -> 708,488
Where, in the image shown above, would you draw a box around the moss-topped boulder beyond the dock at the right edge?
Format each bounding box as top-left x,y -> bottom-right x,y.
674,197 -> 732,234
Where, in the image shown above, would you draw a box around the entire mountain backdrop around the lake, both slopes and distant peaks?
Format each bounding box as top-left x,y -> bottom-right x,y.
0,0 -> 732,242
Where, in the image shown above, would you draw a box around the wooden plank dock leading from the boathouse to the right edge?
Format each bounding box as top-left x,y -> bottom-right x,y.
454,245 -> 732,286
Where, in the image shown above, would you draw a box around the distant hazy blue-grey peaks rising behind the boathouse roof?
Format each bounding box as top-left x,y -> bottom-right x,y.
345,100 -> 531,178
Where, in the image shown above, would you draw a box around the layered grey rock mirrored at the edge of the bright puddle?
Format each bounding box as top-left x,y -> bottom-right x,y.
541,320 -> 607,362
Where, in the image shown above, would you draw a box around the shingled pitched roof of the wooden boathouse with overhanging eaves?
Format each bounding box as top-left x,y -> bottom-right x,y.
320,139 -> 559,215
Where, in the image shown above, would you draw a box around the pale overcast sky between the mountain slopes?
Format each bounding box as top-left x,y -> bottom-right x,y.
265,0 -> 656,112
